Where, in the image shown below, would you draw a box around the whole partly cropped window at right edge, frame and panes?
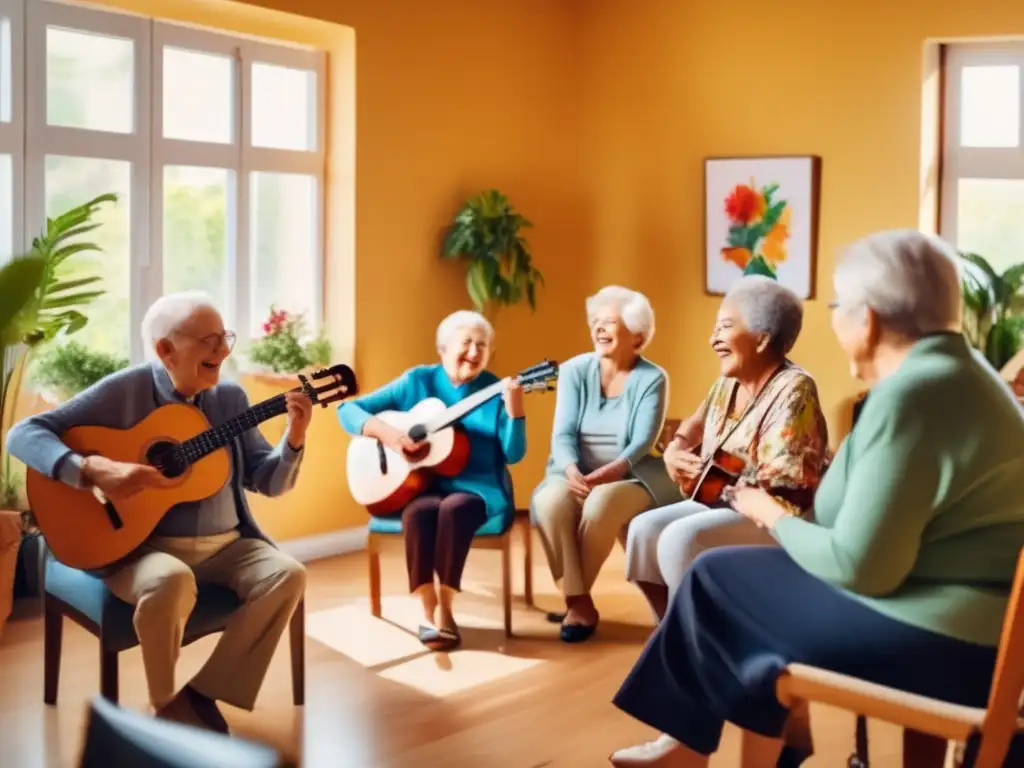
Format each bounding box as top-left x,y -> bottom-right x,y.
940,43 -> 1024,271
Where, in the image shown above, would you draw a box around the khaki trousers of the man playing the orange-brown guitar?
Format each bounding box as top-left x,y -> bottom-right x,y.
104,530 -> 305,710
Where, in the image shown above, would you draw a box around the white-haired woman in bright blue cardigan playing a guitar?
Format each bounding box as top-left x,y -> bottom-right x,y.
338,311 -> 526,650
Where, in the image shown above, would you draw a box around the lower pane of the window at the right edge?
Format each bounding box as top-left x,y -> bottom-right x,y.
956,178 -> 1024,271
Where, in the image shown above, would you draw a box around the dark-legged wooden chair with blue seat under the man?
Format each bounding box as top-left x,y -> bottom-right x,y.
40,540 -> 305,707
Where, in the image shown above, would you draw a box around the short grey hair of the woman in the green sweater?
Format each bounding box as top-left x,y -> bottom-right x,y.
833,229 -> 963,339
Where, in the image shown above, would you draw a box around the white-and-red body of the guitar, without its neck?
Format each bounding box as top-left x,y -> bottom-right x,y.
346,397 -> 469,516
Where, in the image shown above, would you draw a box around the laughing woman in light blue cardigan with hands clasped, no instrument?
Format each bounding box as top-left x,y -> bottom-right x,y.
530,286 -> 680,643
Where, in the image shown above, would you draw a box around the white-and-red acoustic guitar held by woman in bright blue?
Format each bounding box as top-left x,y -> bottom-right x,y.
346,360 -> 558,516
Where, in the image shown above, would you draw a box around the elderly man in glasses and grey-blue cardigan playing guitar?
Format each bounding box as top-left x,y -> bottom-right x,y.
8,293 -> 312,733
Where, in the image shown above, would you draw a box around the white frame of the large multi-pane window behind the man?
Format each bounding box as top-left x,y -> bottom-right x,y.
23,0 -> 327,360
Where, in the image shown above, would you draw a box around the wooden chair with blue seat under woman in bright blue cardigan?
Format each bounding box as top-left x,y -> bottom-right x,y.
367,509 -> 534,637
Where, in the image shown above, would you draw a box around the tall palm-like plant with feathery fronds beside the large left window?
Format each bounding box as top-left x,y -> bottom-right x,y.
0,194 -> 118,506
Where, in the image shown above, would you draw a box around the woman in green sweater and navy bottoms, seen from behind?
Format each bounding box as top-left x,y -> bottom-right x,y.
611,231 -> 1024,768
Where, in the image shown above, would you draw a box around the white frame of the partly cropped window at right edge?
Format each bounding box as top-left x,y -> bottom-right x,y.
939,41 -> 1024,244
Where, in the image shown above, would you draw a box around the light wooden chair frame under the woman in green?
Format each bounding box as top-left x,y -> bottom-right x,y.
776,550 -> 1024,768
